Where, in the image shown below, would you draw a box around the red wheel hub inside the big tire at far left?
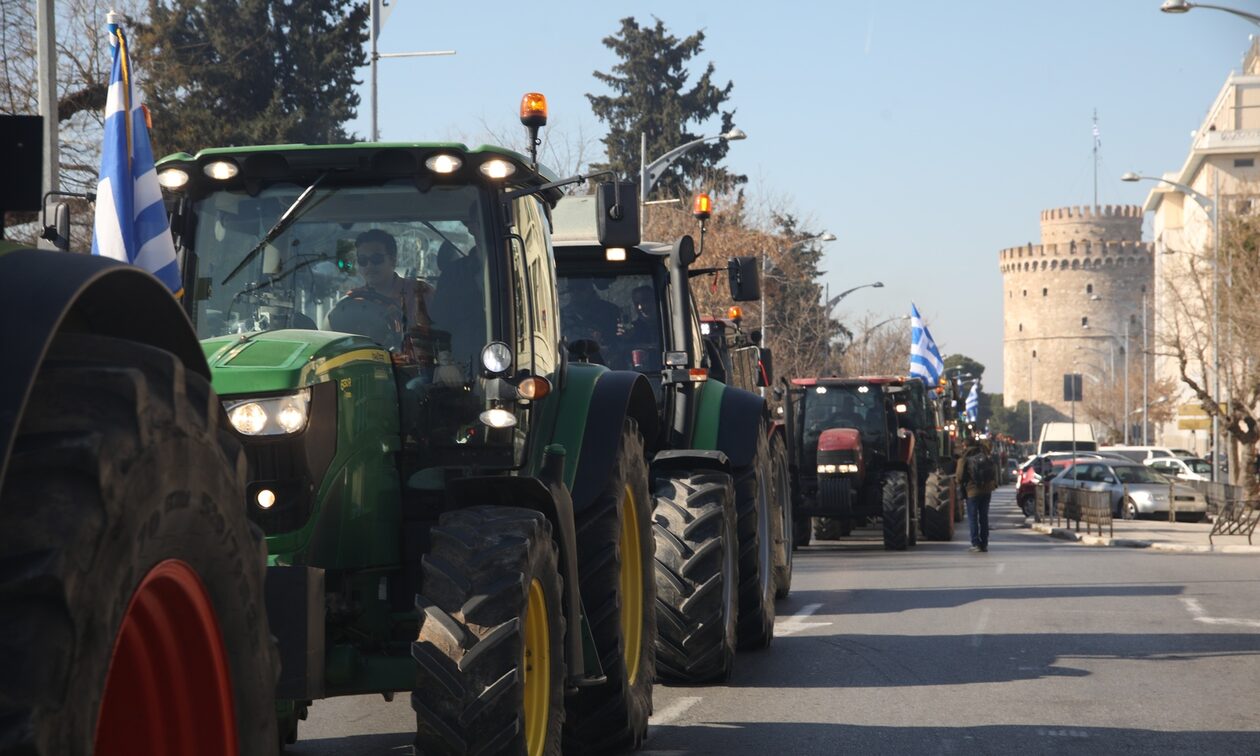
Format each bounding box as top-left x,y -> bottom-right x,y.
96,559 -> 238,756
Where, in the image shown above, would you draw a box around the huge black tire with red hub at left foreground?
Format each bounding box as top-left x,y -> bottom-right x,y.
0,334 -> 280,756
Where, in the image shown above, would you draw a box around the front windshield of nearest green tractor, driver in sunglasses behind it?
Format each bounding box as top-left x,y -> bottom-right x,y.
185,180 -> 491,373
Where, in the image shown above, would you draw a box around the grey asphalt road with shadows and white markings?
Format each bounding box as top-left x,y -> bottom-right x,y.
291,488 -> 1260,756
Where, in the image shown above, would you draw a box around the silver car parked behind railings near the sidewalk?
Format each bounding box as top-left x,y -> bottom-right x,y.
1051,460 -> 1207,522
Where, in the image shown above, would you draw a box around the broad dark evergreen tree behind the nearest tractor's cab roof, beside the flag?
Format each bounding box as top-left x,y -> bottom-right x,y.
132,0 -> 368,155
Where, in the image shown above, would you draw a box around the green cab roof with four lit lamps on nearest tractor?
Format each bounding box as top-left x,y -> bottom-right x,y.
156,142 -> 561,204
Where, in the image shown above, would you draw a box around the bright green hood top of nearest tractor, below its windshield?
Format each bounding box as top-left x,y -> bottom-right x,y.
202,330 -> 392,396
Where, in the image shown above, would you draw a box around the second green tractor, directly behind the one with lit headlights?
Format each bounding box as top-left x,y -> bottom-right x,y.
556,197 -> 782,683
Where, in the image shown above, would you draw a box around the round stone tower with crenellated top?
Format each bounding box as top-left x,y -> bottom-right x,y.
999,205 -> 1154,430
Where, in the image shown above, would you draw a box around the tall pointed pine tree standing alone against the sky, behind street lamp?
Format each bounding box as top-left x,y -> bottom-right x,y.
586,16 -> 747,197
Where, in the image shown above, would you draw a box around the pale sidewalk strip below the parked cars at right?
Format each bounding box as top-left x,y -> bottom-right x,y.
1024,518 -> 1260,554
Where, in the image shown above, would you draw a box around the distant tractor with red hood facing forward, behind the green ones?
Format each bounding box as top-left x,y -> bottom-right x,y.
788,377 -> 920,551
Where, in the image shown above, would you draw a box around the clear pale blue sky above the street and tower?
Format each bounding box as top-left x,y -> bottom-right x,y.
352,0 -> 1260,392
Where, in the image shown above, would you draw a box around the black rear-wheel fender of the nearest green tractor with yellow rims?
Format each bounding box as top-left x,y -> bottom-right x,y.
572,370 -> 660,513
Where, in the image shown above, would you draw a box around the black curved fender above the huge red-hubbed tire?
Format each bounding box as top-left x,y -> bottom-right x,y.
0,249 -> 210,480
